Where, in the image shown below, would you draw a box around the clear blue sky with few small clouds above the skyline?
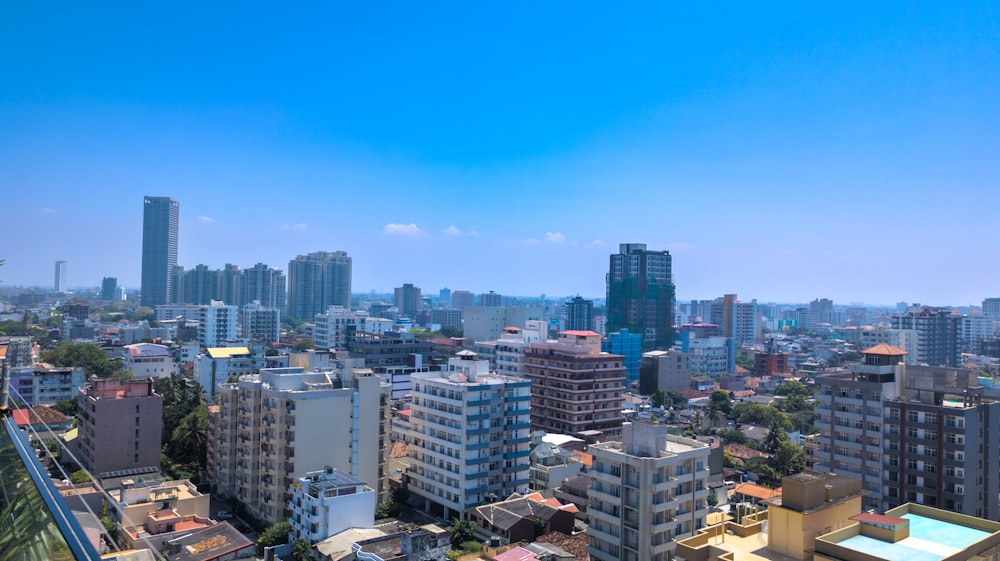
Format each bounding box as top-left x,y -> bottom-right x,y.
0,2 -> 1000,305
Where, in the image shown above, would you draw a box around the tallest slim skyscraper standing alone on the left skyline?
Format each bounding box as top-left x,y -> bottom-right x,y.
141,196 -> 181,308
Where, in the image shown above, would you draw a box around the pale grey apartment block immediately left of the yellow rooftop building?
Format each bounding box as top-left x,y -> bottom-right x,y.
587,421 -> 709,561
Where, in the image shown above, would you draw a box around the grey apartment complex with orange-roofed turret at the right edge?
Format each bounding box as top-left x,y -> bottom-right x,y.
806,344 -> 1000,520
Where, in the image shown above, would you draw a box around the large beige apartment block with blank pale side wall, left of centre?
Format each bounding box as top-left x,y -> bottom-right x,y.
215,368 -> 389,524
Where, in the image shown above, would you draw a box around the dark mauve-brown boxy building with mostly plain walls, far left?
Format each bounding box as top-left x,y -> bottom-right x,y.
77,379 -> 163,476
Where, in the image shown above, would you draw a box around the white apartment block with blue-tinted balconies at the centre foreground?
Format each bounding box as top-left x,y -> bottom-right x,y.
410,351 -> 531,519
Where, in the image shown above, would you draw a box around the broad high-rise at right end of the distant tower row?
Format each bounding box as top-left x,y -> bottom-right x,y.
288,251 -> 352,319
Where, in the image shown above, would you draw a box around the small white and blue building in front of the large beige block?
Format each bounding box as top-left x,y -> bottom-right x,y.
288,466 -> 377,544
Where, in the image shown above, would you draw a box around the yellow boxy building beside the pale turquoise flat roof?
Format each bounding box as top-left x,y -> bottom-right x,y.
767,473 -> 863,559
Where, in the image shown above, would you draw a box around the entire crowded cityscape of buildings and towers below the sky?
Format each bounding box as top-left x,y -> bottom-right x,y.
0,196 -> 1000,561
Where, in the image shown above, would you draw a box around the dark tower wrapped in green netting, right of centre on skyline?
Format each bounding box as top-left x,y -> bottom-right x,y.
607,243 -> 675,351
